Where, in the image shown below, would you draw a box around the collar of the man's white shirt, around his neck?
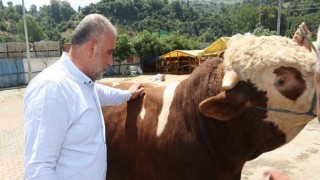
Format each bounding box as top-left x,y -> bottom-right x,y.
61,52 -> 93,86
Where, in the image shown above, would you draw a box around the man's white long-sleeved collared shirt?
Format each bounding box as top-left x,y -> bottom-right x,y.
24,54 -> 131,180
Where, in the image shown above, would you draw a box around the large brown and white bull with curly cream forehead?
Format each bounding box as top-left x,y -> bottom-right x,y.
103,35 -> 316,180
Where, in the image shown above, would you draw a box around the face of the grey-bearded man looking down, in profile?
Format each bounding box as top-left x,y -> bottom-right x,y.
92,32 -> 116,80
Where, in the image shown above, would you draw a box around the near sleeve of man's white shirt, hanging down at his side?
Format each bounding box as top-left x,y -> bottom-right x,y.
24,82 -> 68,179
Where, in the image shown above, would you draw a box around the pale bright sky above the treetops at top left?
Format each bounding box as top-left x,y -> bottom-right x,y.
2,0 -> 100,11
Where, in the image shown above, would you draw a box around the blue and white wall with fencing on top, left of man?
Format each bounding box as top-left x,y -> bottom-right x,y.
0,41 -> 61,88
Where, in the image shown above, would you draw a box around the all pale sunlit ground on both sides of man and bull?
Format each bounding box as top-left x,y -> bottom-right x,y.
0,75 -> 320,180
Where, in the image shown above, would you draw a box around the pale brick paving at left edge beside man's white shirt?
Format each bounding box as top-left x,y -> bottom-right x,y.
0,88 -> 24,180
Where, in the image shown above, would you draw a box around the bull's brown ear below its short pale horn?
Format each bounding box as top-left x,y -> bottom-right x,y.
199,90 -> 250,121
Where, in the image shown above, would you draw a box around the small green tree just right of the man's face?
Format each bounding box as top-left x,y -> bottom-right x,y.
114,33 -> 136,73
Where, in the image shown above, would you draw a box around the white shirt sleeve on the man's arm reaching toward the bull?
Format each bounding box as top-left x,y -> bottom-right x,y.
95,83 -> 131,106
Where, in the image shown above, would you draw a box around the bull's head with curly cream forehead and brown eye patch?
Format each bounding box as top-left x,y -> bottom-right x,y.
200,35 -> 320,141
